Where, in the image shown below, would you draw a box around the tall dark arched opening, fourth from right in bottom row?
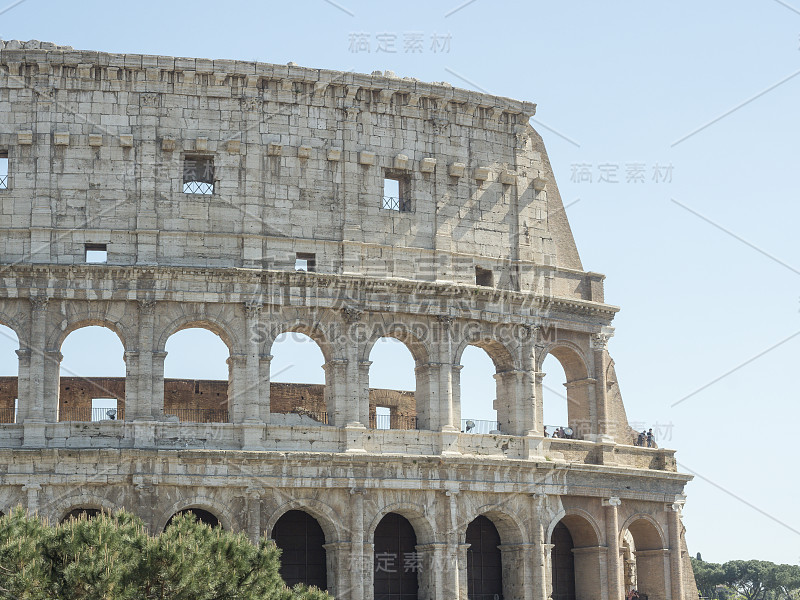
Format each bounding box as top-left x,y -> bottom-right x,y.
373,513 -> 422,600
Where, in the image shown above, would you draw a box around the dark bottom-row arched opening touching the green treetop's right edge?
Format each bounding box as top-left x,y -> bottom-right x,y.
272,510 -> 328,590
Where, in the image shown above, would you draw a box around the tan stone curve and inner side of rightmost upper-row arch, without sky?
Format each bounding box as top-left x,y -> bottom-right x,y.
536,340 -> 598,439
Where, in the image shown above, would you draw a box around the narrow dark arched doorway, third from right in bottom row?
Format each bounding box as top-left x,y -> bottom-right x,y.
466,516 -> 503,600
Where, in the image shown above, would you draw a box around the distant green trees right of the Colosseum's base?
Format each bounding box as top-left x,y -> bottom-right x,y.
692,555 -> 800,600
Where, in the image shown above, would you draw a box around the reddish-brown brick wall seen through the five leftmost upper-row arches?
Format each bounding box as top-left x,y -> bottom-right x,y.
0,377 -> 417,419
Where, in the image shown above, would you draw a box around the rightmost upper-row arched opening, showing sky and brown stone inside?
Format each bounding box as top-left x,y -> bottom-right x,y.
536,346 -> 597,439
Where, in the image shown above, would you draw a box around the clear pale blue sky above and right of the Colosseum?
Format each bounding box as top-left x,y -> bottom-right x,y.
0,0 -> 800,563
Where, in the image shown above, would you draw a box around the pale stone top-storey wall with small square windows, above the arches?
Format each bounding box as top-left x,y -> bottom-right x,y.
0,42 -> 603,302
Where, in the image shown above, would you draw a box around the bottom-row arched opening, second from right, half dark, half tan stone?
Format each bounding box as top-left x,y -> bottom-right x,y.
550,515 -> 603,600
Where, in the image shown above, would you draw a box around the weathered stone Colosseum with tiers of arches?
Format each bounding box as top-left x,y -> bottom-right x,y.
0,41 -> 697,600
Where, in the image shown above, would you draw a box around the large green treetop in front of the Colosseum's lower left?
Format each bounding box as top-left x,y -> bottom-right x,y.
0,508 -> 332,600
